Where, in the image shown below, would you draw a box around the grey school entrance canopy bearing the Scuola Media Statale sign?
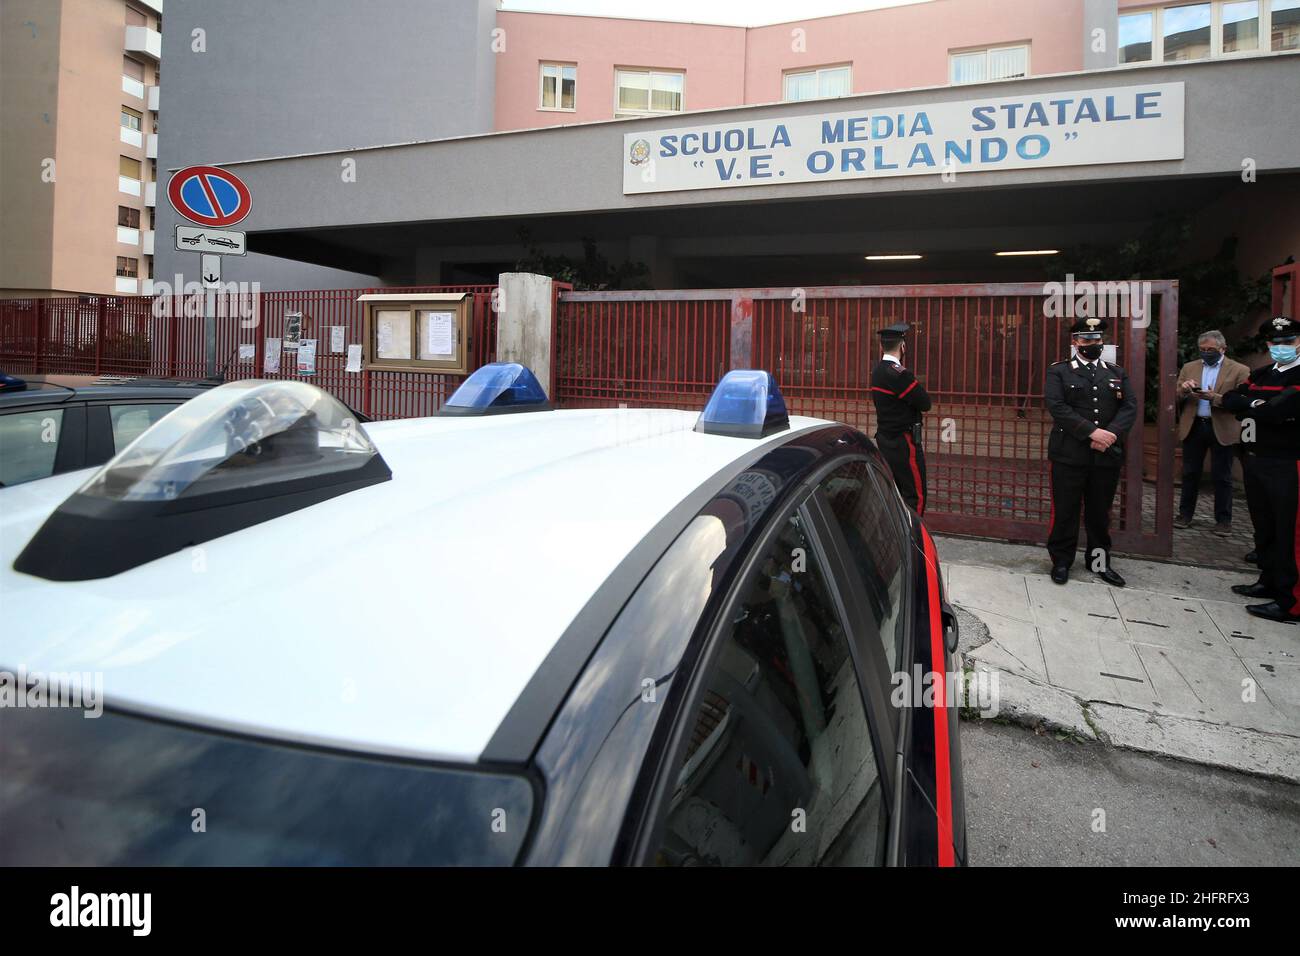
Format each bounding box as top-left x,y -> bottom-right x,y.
157,55 -> 1300,289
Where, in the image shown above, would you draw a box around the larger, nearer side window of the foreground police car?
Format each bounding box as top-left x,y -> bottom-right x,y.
657,516 -> 887,866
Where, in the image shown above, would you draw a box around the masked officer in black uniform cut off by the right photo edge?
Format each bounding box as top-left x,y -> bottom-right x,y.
1219,315 -> 1300,622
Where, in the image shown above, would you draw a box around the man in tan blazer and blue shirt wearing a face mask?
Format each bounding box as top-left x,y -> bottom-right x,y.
1174,332 -> 1251,535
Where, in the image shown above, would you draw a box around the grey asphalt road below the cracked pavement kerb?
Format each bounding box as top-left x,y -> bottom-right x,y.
962,721 -> 1300,866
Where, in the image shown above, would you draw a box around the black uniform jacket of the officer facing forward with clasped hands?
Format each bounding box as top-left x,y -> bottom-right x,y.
1043,358 -> 1138,468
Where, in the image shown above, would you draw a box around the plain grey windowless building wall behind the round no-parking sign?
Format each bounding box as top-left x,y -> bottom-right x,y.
155,0 -> 497,289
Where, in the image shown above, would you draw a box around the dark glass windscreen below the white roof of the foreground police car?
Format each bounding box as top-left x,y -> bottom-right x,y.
0,708 -> 533,866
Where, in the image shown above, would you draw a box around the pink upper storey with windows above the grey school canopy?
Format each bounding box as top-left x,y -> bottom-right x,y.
495,0 -> 1300,130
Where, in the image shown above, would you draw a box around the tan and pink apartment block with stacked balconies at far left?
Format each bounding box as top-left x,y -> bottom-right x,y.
0,0 -> 163,295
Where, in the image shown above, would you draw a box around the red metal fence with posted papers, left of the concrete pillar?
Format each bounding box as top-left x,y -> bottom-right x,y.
0,285 -> 497,419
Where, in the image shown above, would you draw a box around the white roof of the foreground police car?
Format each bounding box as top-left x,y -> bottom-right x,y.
0,410 -> 826,761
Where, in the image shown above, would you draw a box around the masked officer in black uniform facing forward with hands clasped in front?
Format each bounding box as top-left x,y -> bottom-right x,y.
1044,319 -> 1138,588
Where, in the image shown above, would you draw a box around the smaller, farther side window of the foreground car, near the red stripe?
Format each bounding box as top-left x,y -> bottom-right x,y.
822,462 -> 909,674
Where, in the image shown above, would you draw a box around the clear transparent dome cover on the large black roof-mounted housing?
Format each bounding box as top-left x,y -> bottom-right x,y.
79,381 -> 377,501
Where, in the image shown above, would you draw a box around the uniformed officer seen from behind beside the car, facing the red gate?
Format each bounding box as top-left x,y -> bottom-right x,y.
871,323 -> 930,515
